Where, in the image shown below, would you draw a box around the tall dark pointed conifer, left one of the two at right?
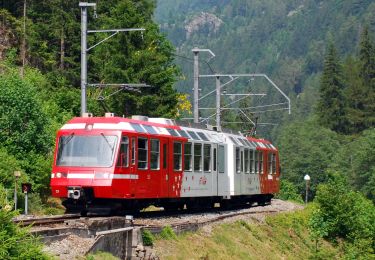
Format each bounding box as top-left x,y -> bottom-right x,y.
316,43 -> 347,133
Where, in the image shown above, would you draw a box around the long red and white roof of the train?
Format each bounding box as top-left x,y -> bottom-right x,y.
61,115 -> 277,151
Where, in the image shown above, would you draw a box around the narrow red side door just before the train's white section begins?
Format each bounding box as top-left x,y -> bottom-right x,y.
159,138 -> 169,198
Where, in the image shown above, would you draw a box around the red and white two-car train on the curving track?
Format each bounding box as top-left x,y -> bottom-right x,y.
51,113 -> 280,213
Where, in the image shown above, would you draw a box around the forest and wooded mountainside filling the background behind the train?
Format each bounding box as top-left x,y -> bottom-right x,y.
0,0 -> 375,259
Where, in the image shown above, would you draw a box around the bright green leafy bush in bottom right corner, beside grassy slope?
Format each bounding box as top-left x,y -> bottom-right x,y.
311,173 -> 375,258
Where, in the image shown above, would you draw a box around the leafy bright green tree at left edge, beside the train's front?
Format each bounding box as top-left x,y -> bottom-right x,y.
0,71 -> 49,156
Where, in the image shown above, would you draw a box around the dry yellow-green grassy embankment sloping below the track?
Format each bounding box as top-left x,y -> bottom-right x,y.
155,209 -> 341,260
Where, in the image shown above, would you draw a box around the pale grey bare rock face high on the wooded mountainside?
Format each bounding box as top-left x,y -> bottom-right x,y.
185,12 -> 223,39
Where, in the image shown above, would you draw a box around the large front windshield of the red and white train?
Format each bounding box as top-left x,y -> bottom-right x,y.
56,134 -> 117,167
